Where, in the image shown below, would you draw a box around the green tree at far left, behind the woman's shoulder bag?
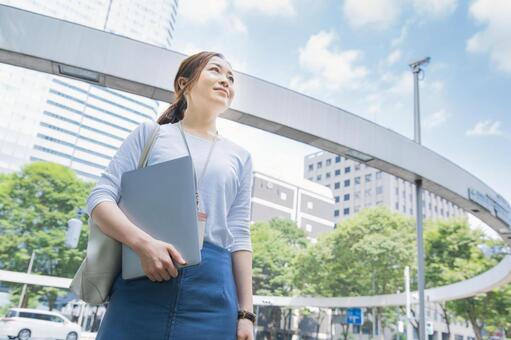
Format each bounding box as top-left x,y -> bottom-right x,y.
0,162 -> 93,309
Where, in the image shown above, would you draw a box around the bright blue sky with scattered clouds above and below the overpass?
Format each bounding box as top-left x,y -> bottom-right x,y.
169,0 -> 511,205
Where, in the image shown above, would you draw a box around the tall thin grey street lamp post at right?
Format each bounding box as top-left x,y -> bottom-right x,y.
409,57 -> 431,340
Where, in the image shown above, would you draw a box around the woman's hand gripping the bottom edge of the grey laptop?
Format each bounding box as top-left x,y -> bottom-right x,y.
135,237 -> 186,282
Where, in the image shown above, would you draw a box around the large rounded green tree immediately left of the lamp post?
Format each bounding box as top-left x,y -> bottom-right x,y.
294,206 -> 415,338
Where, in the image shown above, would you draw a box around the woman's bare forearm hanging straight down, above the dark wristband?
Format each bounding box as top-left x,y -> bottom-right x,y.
232,250 -> 253,312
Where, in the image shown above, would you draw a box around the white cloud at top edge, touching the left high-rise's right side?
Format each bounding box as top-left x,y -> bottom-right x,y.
179,0 -> 228,24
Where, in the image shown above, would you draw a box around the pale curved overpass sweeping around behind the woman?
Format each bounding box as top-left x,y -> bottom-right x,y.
0,5 -> 511,307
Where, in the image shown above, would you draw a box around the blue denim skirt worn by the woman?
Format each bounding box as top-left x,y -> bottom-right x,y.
96,241 -> 238,340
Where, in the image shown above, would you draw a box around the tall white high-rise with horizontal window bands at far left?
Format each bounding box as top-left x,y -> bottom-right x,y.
0,0 -> 178,181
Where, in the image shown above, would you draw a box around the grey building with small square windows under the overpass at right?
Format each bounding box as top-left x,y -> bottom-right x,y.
304,151 -> 466,221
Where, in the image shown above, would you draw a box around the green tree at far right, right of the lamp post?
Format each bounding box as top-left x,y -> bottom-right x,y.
425,218 -> 511,339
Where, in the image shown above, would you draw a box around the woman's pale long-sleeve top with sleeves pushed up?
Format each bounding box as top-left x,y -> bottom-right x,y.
87,120 -> 253,252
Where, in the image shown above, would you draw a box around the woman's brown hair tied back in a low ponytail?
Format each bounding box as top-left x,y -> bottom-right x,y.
156,51 -> 225,125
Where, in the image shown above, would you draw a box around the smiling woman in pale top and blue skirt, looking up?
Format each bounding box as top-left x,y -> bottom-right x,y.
87,52 -> 253,340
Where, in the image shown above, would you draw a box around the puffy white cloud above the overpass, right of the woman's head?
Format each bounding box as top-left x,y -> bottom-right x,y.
290,31 -> 368,92
